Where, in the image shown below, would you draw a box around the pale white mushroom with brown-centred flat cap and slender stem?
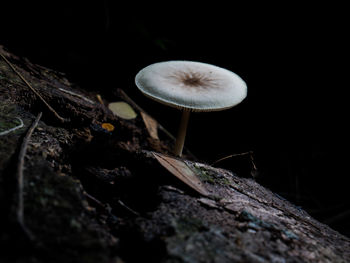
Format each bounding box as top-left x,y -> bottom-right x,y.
135,61 -> 247,156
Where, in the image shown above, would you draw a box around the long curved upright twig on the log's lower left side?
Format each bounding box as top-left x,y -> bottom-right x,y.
16,112 -> 42,240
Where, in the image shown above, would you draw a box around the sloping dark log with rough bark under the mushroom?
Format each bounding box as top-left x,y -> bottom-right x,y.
0,46 -> 350,262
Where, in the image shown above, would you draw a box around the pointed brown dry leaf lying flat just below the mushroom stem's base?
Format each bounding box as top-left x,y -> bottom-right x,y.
152,152 -> 209,196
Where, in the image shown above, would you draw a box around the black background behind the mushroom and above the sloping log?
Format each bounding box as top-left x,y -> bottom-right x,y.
0,0 -> 350,235
